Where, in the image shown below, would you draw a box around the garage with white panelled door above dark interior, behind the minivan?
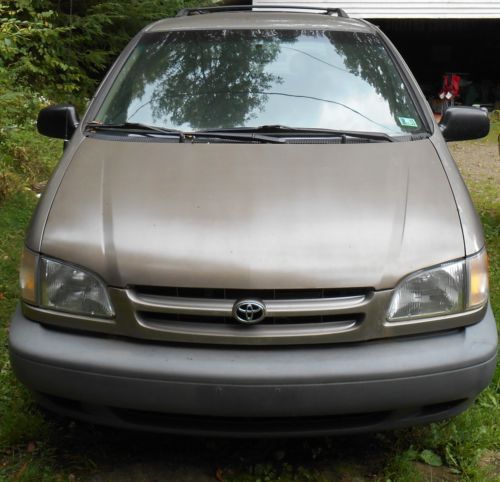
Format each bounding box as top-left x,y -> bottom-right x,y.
253,0 -> 500,112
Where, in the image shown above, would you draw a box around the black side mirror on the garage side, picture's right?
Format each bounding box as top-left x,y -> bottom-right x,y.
439,107 -> 490,141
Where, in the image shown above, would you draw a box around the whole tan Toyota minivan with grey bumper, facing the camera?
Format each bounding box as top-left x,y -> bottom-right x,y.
10,6 -> 497,436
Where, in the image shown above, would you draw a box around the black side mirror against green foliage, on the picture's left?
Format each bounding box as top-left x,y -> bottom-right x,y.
36,104 -> 79,141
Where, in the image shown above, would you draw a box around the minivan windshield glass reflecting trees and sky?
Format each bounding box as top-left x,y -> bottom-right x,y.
96,29 -> 423,135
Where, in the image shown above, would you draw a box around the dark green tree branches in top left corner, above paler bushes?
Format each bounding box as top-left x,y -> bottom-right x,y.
0,0 -> 213,100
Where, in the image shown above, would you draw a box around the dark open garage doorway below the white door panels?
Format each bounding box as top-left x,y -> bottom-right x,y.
376,19 -> 500,110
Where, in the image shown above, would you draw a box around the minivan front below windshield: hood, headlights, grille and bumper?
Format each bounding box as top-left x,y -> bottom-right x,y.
10,139 -> 496,435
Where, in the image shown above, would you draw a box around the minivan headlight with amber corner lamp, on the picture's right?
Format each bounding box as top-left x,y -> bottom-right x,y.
387,249 -> 488,322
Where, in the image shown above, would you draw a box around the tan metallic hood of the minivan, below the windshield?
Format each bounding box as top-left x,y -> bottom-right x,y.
41,135 -> 464,289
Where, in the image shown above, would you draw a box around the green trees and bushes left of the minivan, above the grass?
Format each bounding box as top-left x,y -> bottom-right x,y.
0,0 -> 213,202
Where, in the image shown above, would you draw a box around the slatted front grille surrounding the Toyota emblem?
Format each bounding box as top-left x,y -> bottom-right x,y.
125,286 -> 373,345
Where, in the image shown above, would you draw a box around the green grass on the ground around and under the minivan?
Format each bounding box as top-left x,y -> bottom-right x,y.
0,122 -> 500,482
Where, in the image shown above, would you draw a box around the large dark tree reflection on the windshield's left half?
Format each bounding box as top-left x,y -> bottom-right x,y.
103,30 -> 290,129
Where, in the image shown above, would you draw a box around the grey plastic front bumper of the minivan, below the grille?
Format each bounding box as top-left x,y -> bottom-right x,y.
10,308 -> 497,435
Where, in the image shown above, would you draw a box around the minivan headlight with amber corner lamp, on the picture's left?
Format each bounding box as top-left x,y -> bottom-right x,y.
21,250 -> 114,318
